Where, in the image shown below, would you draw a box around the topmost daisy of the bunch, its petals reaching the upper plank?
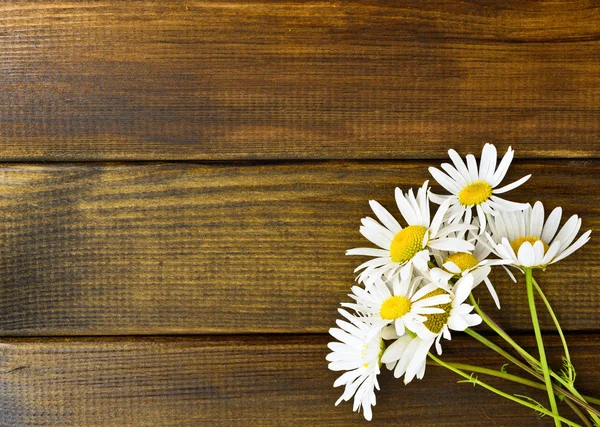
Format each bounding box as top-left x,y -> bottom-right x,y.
429,144 -> 531,234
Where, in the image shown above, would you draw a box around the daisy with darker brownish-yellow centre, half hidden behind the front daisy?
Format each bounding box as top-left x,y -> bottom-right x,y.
381,274 -> 481,384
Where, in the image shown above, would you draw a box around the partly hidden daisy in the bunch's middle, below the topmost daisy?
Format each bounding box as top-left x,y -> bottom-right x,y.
433,220 -> 511,309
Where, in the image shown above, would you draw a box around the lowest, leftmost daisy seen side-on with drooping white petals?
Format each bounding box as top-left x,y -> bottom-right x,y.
326,309 -> 385,421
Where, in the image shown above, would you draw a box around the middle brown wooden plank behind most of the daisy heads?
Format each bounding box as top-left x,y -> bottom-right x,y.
0,161 -> 600,336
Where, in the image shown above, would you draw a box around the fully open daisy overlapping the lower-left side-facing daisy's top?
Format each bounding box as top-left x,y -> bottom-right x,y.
342,276 -> 450,342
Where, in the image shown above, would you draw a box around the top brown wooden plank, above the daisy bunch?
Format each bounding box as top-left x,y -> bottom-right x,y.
0,0 -> 600,160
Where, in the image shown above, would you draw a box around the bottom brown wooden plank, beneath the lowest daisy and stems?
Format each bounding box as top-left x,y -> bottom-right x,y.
0,335 -> 600,427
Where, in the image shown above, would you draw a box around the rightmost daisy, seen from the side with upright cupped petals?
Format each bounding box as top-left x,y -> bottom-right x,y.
488,202 -> 592,268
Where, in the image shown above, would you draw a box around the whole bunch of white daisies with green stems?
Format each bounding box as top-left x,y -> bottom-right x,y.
327,144 -> 600,426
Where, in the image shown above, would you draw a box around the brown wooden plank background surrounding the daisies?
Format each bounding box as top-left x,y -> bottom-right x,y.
0,0 -> 600,427
